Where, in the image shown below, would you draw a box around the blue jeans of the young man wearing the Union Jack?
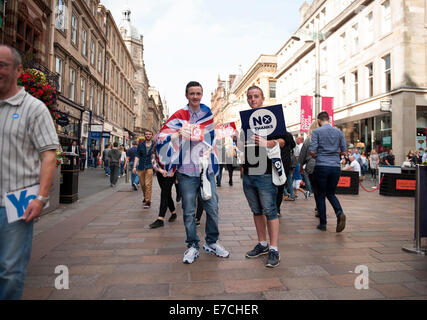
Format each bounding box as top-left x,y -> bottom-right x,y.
178,172 -> 219,249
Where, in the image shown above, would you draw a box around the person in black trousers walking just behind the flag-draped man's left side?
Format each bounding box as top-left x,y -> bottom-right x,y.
150,139 -> 176,229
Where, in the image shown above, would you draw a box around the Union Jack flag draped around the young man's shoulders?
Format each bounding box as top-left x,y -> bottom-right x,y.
156,104 -> 219,175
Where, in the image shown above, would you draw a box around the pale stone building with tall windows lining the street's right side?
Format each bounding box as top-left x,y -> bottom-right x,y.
274,0 -> 427,164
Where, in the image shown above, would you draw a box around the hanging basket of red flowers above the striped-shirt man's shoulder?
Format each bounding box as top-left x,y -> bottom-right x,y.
18,69 -> 59,120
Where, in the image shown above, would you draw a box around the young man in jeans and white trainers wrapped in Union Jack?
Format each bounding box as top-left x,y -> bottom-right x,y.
156,81 -> 230,264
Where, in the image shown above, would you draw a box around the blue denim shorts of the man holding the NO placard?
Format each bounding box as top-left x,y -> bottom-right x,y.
243,174 -> 277,220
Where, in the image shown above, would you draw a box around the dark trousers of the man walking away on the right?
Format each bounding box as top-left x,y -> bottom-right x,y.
313,166 -> 343,226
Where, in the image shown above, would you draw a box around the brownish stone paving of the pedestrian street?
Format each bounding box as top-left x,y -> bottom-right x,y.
24,172 -> 427,300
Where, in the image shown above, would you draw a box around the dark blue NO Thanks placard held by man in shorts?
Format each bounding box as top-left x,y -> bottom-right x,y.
240,104 -> 286,139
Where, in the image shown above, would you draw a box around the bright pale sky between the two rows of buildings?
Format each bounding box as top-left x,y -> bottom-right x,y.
101,0 -> 311,115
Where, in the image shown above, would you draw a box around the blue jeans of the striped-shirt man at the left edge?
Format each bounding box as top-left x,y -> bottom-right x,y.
0,207 -> 33,300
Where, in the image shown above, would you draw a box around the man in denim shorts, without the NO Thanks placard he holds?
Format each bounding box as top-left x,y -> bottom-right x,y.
239,86 -> 286,268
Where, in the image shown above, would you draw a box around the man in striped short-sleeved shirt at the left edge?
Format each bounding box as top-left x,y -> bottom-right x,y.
0,45 -> 59,300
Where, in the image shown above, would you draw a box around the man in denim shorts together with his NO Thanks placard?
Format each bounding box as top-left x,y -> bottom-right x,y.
240,86 -> 286,268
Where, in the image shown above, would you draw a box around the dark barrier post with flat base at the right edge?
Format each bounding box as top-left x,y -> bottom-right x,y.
402,165 -> 427,255
